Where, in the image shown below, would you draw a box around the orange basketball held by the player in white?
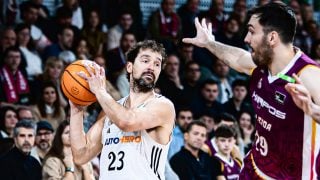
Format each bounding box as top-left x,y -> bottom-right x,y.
61,60 -> 97,106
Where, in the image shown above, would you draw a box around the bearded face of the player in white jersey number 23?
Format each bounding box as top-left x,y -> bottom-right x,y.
127,49 -> 162,92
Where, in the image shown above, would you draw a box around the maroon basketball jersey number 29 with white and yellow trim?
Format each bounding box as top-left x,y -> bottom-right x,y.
247,51 -> 320,179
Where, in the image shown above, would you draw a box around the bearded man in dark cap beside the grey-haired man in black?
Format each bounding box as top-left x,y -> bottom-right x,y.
31,121 -> 54,164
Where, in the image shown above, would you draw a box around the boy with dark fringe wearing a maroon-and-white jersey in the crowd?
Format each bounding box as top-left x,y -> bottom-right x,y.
213,125 -> 242,180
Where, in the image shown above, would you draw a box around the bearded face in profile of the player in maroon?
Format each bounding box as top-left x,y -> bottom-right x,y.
244,15 -> 273,66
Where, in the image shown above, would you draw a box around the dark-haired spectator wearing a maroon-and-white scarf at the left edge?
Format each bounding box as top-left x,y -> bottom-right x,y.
0,47 -> 31,105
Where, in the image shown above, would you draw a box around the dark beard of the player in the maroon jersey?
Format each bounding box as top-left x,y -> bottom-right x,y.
252,35 -> 274,67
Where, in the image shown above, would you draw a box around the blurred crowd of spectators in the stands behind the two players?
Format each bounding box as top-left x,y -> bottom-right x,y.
0,0 -> 320,179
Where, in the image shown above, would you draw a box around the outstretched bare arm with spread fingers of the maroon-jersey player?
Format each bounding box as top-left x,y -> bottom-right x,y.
182,18 -> 256,74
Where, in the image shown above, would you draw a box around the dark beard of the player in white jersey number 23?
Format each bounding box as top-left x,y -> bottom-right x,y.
133,72 -> 155,92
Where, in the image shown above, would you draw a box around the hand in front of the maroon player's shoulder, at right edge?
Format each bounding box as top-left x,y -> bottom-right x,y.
285,74 -> 313,115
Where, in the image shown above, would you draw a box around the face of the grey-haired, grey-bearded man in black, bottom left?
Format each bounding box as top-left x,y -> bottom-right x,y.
14,127 -> 35,155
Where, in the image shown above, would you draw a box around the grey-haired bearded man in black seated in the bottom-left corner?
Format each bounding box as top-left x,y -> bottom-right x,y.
0,120 -> 42,180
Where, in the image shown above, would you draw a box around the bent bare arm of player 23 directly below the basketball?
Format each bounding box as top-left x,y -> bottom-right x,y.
69,101 -> 105,165
